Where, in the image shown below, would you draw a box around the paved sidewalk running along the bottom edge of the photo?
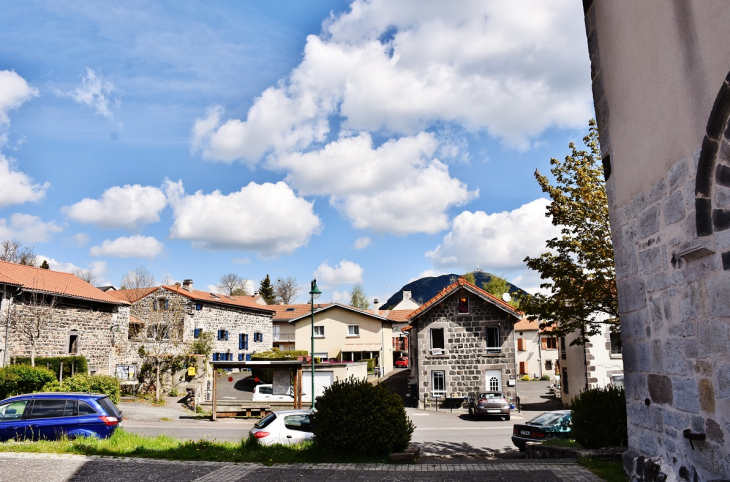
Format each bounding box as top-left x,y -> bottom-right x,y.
0,453 -> 601,482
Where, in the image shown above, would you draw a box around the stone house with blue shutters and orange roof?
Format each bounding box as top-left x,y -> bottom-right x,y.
110,280 -> 274,361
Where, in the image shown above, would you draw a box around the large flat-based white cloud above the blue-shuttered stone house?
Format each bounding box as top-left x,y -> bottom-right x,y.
167,182 -> 321,258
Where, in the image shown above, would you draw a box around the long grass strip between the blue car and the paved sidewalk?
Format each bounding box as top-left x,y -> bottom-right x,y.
0,429 -> 387,464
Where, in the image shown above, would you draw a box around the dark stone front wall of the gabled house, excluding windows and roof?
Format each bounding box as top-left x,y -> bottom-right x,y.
411,290 -> 517,409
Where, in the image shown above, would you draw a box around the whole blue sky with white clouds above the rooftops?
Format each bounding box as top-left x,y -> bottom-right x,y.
0,0 -> 593,301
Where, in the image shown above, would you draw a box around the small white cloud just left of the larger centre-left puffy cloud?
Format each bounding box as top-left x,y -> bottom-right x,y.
62,184 -> 167,230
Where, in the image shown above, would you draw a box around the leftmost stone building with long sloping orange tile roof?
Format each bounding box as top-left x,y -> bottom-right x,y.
0,261 -> 129,374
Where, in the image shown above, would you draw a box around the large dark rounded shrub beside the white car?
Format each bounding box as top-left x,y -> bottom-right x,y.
312,377 -> 415,455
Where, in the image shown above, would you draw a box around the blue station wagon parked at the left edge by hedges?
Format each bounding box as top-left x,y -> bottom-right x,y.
0,393 -> 122,442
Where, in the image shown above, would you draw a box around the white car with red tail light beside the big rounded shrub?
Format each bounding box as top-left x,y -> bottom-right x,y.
249,410 -> 314,445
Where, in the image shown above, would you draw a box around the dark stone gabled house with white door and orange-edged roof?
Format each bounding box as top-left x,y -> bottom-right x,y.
408,278 -> 522,409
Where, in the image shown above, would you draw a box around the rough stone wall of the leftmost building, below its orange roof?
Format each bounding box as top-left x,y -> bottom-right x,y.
0,294 -> 129,374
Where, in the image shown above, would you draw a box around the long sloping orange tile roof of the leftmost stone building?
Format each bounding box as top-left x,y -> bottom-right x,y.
0,261 -> 128,305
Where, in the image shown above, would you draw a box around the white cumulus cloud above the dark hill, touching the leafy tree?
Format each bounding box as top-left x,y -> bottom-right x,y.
426,198 -> 560,272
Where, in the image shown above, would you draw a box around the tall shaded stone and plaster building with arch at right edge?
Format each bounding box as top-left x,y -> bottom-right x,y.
583,0 -> 730,481
